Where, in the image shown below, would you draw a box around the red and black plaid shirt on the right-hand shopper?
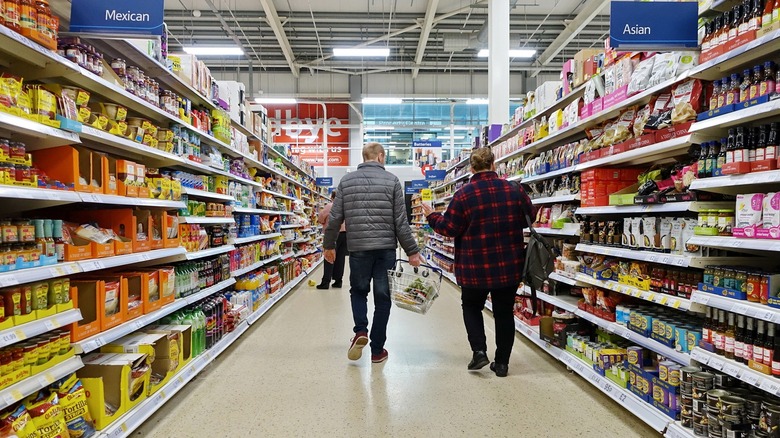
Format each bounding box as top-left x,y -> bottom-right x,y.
428,172 -> 533,289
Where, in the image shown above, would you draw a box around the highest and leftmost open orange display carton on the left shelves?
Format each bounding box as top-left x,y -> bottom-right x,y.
32,146 -> 92,193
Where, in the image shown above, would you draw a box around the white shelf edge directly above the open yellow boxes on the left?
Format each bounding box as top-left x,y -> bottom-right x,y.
73,277 -> 236,354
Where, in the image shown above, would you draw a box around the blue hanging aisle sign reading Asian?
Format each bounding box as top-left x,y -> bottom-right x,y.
609,1 -> 699,51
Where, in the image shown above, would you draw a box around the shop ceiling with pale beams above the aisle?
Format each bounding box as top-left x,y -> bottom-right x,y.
165,0 -> 609,77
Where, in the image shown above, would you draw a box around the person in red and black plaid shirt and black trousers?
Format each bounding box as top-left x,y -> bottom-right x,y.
423,148 -> 533,377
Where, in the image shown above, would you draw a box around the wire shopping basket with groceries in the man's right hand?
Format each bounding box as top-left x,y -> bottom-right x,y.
387,260 -> 443,315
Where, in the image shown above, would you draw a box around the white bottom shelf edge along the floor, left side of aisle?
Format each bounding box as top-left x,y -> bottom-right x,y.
98,259 -> 322,438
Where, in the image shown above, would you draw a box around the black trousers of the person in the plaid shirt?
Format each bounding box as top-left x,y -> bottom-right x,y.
461,286 -> 517,365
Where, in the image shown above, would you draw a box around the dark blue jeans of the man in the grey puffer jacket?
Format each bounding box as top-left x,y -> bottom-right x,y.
349,249 -> 395,354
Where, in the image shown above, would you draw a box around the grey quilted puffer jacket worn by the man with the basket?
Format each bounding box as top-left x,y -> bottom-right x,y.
322,161 -> 419,255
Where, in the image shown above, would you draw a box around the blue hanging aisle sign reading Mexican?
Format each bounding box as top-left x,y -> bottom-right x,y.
70,0 -> 164,35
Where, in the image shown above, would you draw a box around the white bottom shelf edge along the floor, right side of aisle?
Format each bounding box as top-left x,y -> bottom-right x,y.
485,301 -> 684,436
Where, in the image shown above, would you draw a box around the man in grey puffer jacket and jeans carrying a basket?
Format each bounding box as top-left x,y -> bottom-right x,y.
322,143 -> 422,363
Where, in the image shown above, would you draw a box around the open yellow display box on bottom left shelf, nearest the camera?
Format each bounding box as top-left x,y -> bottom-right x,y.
76,353 -> 151,430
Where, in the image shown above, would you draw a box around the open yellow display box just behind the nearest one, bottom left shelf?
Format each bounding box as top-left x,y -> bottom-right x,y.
100,333 -> 180,395
